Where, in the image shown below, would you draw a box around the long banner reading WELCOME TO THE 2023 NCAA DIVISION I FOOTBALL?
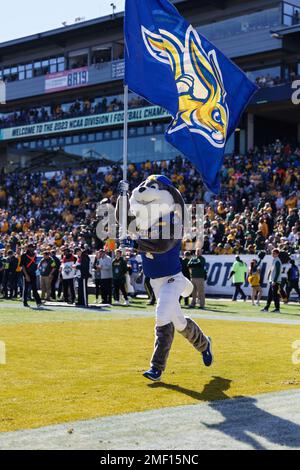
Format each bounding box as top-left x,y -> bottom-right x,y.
0,106 -> 169,140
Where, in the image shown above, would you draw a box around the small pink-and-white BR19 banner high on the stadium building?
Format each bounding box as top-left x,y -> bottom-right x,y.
45,67 -> 89,93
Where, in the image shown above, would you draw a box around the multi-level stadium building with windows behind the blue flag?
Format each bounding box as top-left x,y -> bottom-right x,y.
0,0 -> 300,171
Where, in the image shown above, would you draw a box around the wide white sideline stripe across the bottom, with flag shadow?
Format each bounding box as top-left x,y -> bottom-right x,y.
0,389 -> 300,450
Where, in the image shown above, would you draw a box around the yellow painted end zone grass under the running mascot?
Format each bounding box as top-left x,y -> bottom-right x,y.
0,318 -> 300,431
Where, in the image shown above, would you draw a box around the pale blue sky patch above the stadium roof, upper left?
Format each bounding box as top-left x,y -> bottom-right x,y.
0,0 -> 125,42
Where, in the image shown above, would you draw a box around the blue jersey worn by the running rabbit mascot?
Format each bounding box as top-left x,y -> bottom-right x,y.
142,240 -> 182,279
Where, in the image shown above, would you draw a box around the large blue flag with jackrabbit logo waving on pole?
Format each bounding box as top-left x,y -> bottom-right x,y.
125,0 -> 257,193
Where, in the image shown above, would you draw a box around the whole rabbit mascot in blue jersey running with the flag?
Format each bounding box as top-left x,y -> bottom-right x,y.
117,175 -> 213,381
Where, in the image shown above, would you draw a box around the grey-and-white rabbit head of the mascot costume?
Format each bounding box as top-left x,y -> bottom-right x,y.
130,175 -> 184,230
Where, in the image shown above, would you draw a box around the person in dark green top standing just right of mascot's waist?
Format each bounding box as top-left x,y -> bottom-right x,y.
188,249 -> 206,309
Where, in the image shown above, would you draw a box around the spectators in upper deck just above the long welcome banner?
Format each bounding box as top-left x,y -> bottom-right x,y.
0,95 -> 149,128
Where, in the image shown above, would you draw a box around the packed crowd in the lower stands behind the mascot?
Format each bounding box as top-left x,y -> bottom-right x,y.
0,140 -> 300,260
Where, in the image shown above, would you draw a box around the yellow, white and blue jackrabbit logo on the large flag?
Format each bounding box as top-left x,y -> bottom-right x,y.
142,26 -> 229,148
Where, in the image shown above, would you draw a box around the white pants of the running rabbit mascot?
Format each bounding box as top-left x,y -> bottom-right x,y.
151,273 -> 193,331
